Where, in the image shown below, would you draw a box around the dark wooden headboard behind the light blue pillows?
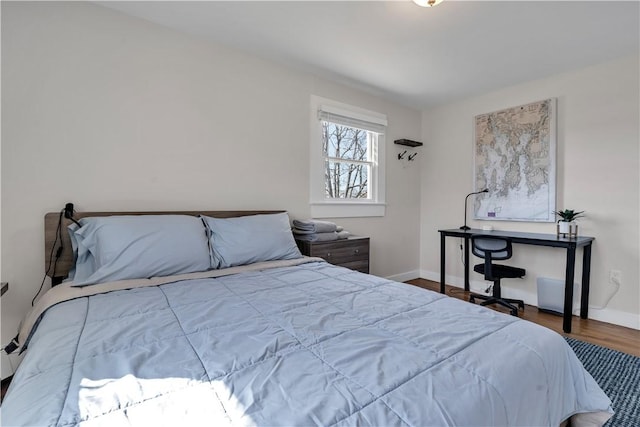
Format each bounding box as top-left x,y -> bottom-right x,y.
44,210 -> 286,285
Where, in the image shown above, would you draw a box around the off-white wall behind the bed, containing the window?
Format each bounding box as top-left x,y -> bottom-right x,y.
1,2 -> 421,374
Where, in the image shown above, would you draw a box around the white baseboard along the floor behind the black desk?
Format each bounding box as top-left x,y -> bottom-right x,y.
420,270 -> 640,330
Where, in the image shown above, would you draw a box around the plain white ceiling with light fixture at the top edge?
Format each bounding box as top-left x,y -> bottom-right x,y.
98,0 -> 640,109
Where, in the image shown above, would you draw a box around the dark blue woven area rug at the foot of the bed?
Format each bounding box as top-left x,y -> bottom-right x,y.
565,337 -> 640,427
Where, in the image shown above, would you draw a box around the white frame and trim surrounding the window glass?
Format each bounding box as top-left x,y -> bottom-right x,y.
309,95 -> 387,218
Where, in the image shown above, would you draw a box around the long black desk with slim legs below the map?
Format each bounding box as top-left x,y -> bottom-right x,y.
438,228 -> 595,333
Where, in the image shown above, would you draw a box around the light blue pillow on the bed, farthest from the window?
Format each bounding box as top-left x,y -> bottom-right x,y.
70,215 -> 211,286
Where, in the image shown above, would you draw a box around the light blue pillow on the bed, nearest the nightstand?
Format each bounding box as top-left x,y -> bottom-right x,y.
202,212 -> 302,268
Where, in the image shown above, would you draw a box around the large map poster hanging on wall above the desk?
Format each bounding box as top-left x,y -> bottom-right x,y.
473,98 -> 556,222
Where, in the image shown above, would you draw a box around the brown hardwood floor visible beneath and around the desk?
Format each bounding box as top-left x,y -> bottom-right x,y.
407,279 -> 640,357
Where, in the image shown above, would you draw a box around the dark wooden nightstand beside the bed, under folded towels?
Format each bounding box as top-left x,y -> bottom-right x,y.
296,236 -> 369,273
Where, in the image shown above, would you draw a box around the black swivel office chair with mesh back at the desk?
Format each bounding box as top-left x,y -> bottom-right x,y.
469,234 -> 526,317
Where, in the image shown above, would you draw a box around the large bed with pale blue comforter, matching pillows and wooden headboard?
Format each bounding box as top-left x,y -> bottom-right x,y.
2,212 -> 612,426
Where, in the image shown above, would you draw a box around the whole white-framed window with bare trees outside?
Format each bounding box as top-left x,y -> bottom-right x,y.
310,97 -> 387,217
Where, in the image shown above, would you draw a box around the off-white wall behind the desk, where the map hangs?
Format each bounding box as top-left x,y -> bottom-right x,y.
420,56 -> 640,328
